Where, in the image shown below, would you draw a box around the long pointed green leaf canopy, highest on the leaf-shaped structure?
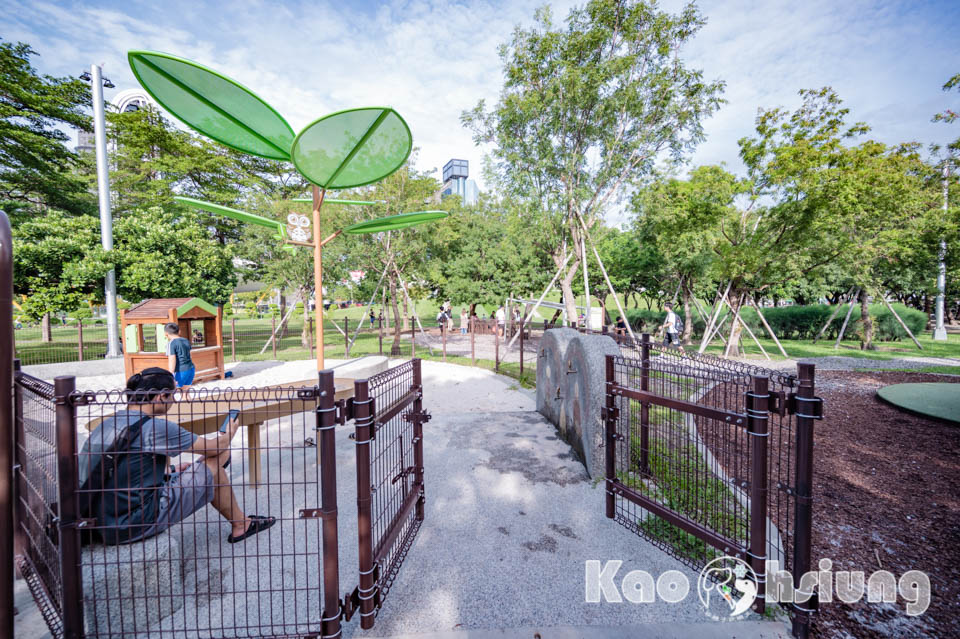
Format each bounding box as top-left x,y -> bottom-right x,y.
127,51 -> 293,160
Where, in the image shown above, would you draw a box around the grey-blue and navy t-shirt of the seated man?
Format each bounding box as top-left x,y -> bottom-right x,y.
80,410 -> 197,543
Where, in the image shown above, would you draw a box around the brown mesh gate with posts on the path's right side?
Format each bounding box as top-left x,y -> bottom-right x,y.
603,335 -> 822,637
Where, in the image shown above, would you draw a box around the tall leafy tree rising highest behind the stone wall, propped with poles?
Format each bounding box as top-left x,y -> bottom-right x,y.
461,0 -> 723,317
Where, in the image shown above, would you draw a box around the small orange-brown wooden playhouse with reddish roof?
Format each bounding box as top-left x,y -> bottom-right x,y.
120,297 -> 224,382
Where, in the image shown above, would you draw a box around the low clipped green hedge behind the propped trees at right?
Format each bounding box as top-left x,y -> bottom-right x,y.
613,303 -> 927,342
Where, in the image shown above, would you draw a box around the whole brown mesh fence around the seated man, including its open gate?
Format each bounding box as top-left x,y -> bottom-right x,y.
10,360 -> 429,639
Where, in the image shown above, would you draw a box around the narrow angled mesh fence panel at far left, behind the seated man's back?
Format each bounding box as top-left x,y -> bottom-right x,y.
14,372 -> 63,637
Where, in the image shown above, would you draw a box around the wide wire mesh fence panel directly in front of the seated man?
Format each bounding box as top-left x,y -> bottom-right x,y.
70,387 -> 332,639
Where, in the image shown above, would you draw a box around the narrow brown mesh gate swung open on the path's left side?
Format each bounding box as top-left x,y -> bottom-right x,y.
353,359 -> 430,628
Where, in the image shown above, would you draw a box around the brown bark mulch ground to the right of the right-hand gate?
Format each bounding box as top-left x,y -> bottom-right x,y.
812,371 -> 960,639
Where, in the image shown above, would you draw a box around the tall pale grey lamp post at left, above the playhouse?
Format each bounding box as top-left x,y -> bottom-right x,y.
81,64 -> 120,357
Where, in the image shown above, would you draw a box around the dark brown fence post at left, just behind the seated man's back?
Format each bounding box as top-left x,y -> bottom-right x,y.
53,376 -> 84,639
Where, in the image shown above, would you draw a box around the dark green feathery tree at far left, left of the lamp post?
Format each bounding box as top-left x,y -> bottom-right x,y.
0,42 -> 95,217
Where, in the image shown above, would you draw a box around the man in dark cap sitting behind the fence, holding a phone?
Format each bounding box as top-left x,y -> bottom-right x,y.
80,368 -> 276,544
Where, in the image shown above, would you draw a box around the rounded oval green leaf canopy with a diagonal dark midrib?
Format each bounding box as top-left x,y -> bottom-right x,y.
290,107 -> 413,189
